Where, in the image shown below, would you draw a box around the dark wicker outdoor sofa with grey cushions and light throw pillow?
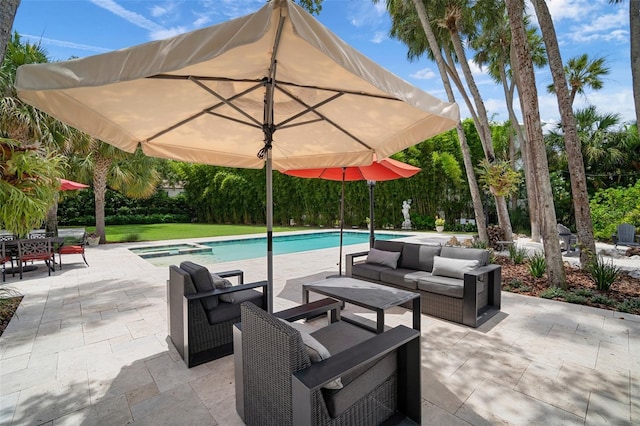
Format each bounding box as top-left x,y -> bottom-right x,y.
346,240 -> 502,327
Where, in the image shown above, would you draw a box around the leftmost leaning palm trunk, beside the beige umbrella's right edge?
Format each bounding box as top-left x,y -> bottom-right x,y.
413,0 -> 489,243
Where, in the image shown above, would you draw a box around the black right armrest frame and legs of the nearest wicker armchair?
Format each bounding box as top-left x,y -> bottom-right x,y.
291,325 -> 422,425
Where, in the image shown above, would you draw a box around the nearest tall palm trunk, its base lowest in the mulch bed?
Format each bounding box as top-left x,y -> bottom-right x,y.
506,0 -> 566,288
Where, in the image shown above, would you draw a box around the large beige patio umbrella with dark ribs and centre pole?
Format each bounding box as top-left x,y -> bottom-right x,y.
16,0 -> 459,310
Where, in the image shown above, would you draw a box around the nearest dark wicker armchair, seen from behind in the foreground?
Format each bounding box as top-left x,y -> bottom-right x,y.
235,303 -> 421,426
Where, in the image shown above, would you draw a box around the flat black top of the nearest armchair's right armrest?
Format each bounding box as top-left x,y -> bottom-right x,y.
292,325 -> 420,395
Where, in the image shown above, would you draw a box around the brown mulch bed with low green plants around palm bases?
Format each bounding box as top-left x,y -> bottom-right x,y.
496,256 -> 640,314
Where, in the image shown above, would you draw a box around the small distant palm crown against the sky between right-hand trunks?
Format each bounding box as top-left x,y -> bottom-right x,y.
547,53 -> 610,105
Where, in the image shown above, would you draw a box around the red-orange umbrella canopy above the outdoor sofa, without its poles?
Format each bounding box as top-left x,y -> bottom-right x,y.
281,158 -> 421,181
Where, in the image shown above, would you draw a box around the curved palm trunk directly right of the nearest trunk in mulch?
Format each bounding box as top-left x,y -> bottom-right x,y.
533,0 -> 596,268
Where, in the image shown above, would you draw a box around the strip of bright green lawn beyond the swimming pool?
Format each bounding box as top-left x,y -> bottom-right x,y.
79,223 -> 295,243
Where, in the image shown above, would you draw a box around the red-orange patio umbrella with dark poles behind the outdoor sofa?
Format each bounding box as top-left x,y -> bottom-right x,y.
281,155 -> 421,275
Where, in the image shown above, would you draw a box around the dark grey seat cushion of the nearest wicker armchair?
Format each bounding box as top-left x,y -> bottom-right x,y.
311,321 -> 397,417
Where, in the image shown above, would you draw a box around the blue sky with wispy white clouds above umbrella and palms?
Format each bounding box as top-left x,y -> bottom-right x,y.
14,0 -> 635,123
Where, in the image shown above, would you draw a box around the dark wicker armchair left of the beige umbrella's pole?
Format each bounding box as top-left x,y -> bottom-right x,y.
167,262 -> 267,368
